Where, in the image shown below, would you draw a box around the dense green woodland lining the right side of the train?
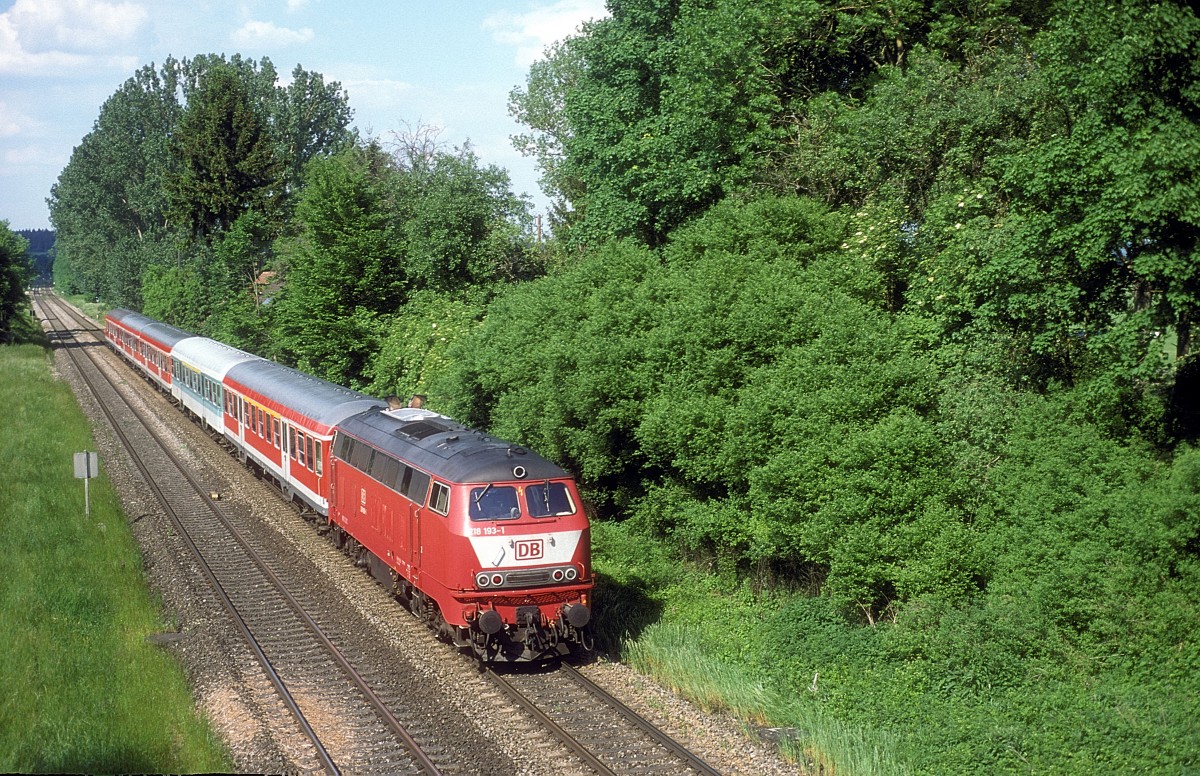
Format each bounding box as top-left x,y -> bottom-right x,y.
50,0 -> 1200,774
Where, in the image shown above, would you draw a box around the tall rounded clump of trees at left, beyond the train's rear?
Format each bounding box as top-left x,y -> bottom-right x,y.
50,54 -> 350,316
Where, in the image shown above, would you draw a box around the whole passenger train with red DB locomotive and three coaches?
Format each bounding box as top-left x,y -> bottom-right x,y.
104,309 -> 594,663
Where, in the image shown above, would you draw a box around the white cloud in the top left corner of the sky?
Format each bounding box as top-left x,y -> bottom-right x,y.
0,0 -> 148,76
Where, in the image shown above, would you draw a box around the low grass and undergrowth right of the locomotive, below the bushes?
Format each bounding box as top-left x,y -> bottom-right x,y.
593,523 -> 1200,776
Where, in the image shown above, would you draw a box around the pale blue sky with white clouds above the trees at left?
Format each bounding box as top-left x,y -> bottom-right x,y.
0,0 -> 605,229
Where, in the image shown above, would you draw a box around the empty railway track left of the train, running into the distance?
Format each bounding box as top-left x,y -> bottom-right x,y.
35,296 -> 452,775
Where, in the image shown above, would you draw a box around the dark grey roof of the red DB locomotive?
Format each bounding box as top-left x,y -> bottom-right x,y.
338,408 -> 568,482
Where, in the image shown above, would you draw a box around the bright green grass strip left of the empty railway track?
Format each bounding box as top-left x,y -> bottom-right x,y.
0,307 -> 230,772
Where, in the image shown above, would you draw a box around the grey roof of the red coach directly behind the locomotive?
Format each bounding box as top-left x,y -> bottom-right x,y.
227,359 -> 386,431
